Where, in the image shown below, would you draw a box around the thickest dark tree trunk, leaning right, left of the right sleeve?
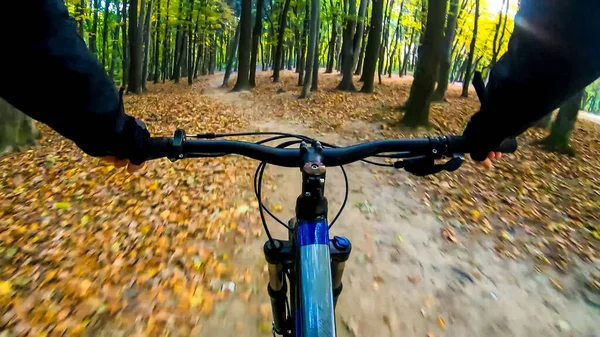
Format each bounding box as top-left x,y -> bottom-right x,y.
402,0 -> 448,127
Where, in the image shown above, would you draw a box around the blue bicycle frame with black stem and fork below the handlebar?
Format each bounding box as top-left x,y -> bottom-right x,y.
264,144 -> 351,337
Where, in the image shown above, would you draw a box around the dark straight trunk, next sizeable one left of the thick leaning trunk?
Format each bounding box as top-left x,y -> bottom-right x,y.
360,0 -> 384,93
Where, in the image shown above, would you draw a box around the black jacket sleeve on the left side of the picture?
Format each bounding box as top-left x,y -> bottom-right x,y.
0,0 -> 149,162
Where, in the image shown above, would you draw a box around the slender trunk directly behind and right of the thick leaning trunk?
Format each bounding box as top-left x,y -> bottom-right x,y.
431,0 -> 458,101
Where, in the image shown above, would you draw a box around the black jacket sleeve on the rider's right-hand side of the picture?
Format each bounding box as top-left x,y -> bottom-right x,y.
465,0 -> 600,160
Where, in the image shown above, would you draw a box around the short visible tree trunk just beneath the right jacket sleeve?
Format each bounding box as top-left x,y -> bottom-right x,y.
540,91 -> 583,155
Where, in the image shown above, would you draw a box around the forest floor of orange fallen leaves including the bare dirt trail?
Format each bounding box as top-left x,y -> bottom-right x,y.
0,71 -> 600,337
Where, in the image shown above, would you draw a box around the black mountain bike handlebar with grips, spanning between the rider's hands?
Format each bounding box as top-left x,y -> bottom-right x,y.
147,130 -> 517,167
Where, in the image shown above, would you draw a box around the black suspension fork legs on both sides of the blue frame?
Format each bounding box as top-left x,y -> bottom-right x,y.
264,236 -> 352,336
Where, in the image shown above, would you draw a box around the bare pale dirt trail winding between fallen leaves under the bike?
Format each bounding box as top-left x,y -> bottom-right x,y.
201,76 -> 600,337
